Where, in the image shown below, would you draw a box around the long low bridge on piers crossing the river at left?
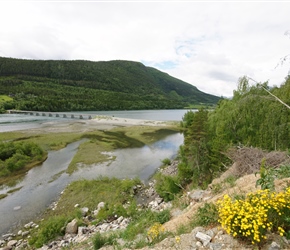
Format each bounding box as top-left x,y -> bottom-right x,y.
8,110 -> 93,120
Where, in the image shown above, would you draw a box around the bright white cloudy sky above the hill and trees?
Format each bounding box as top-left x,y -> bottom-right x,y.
0,0 -> 290,96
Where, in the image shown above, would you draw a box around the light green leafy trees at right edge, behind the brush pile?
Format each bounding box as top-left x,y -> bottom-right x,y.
209,77 -> 290,150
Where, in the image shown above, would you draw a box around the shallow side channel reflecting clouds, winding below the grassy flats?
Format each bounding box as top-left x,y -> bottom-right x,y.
0,111 -> 189,236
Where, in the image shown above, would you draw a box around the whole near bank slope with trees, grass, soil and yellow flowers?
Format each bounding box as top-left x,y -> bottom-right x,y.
0,77 -> 290,250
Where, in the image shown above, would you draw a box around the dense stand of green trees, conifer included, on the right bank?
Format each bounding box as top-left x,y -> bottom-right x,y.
153,77 -> 290,195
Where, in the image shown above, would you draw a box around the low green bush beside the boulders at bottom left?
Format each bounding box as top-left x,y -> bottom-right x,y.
29,216 -> 68,248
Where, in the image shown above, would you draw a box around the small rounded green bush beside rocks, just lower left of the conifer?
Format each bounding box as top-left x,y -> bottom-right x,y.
155,174 -> 180,201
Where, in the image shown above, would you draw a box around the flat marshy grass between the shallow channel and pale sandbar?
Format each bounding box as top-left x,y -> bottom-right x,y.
0,126 -> 178,180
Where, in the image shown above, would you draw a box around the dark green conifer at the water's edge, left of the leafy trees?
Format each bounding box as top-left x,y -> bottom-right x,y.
178,109 -> 226,188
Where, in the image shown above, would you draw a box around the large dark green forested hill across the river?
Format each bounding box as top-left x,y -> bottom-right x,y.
0,58 -> 219,111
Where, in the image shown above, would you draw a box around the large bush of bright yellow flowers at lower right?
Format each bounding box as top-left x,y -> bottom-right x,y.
217,187 -> 290,244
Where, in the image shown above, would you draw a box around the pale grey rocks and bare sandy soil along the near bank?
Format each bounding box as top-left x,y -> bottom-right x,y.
0,159 -> 290,250
